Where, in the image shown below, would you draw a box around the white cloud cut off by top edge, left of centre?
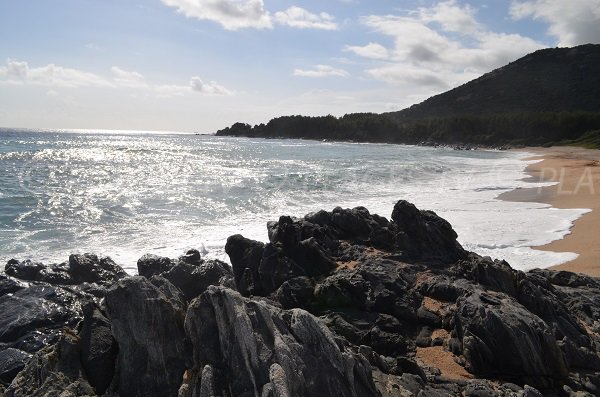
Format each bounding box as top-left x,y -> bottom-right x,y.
162,0 -> 273,30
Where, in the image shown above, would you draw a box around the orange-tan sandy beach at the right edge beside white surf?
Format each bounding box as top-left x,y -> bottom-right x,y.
498,146 -> 600,277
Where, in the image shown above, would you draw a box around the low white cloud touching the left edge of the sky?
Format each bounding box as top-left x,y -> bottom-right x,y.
0,59 -> 113,87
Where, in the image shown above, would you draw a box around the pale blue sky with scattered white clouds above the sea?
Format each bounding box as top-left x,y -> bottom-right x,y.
0,0 -> 600,133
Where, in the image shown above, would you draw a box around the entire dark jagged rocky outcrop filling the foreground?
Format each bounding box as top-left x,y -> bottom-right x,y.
0,201 -> 600,397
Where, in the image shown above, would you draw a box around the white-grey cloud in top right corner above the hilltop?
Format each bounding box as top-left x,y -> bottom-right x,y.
510,0 -> 600,46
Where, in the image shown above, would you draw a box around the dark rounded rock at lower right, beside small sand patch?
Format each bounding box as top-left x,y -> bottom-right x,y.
455,292 -> 568,388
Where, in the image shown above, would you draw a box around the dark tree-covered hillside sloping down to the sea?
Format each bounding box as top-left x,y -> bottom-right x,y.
217,44 -> 600,147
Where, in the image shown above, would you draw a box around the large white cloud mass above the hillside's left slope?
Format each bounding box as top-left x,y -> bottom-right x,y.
345,0 -> 544,90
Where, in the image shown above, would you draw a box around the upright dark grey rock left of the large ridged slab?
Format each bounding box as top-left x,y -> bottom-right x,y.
106,276 -> 189,396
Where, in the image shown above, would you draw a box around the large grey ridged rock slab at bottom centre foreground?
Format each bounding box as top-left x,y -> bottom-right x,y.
185,286 -> 378,396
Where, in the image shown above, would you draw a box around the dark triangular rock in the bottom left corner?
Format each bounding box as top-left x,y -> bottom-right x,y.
4,330 -> 96,397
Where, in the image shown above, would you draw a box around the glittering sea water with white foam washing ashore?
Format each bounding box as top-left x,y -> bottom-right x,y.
0,129 -> 585,273
